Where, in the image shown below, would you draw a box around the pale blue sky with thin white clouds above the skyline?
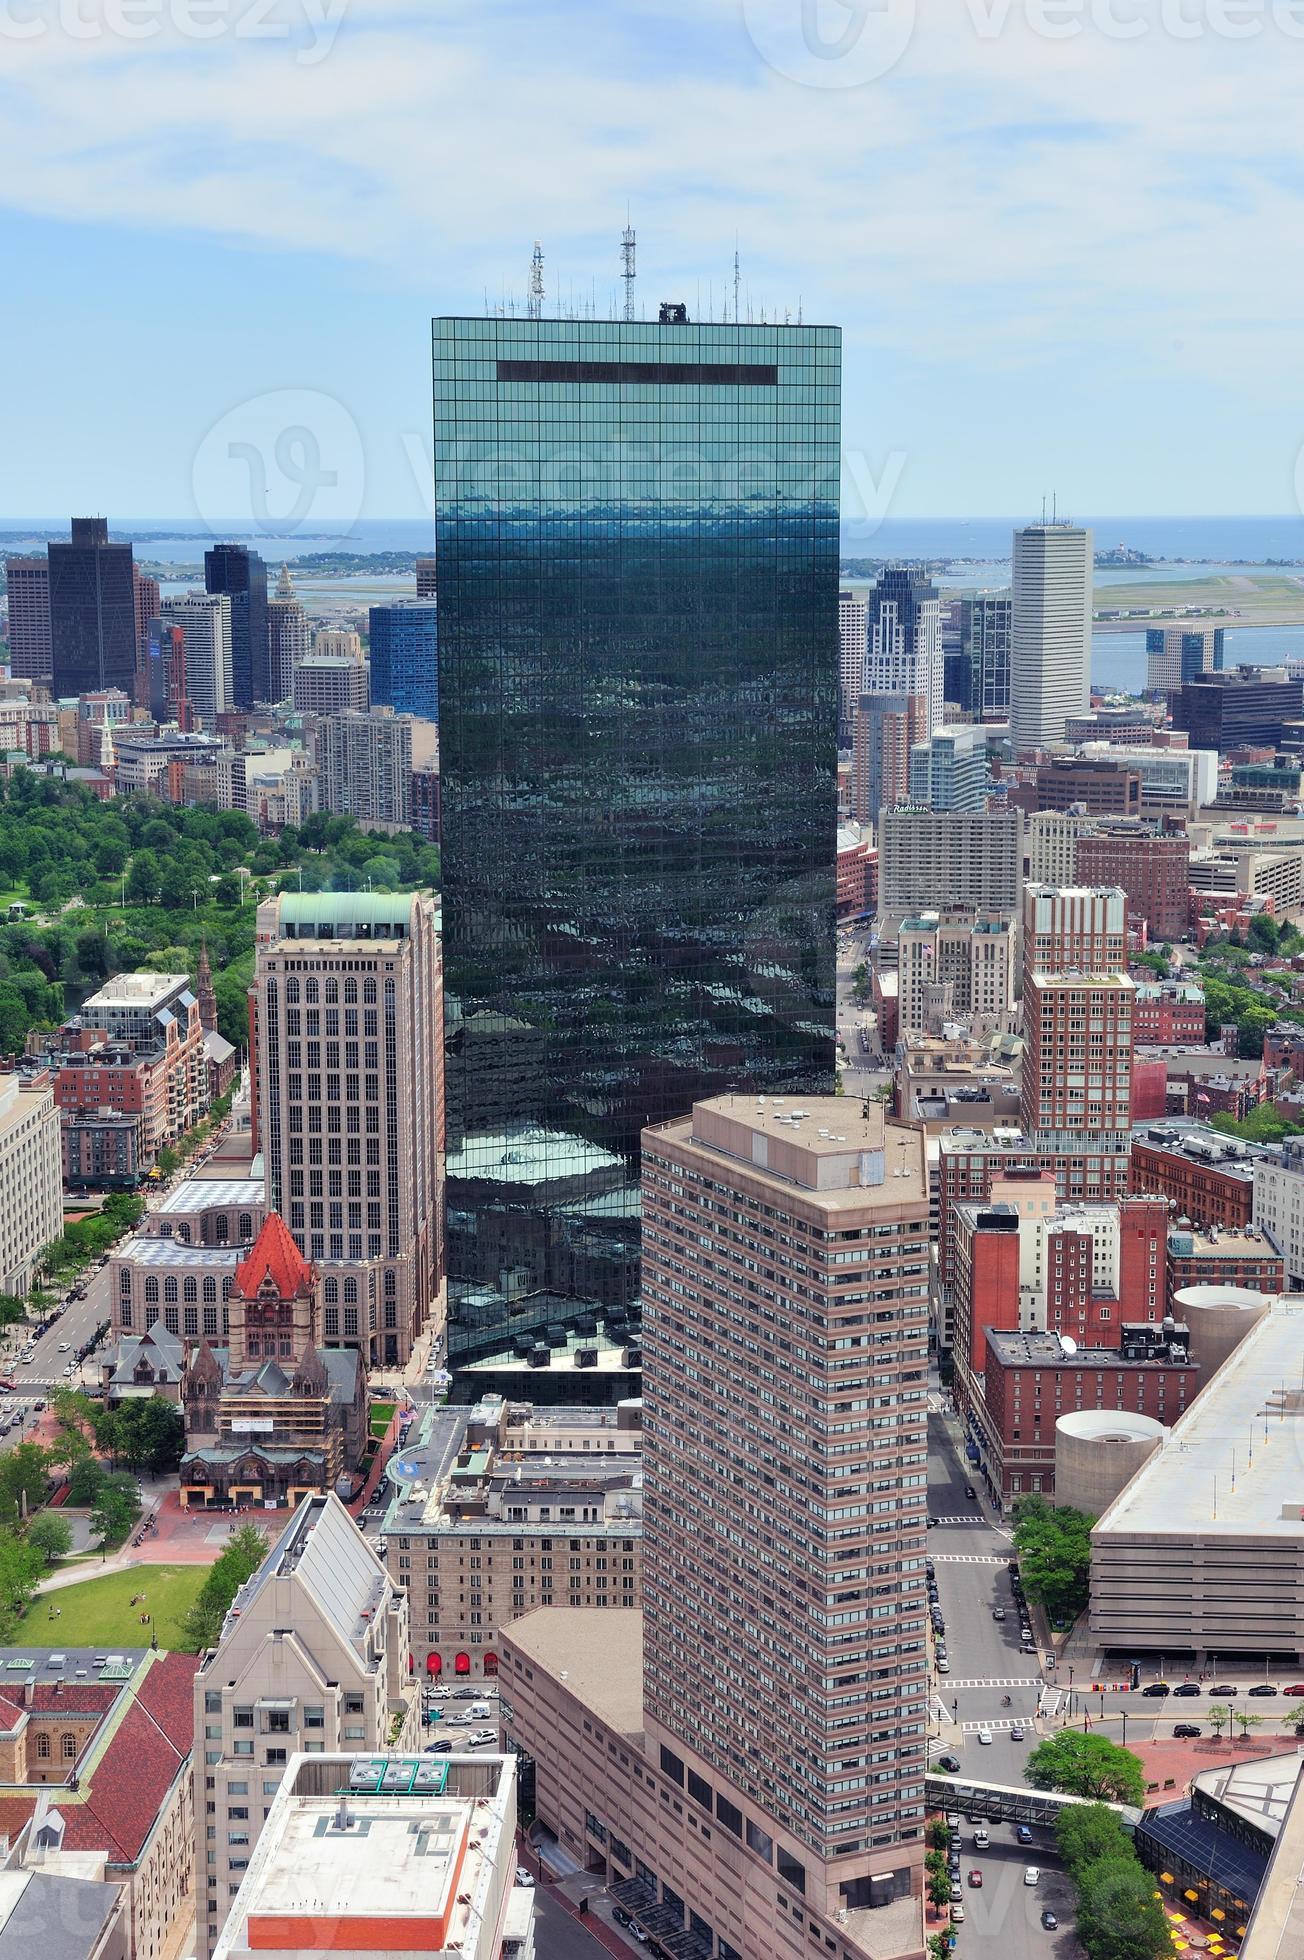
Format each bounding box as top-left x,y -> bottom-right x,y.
0,0 -> 1304,529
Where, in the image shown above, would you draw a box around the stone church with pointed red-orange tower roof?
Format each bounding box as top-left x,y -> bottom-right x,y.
180,1211 -> 367,1507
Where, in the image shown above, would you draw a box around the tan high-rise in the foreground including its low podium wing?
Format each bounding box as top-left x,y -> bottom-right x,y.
502,1096 -> 929,1960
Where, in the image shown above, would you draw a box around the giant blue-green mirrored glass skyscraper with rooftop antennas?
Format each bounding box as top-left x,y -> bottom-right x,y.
433,319 -> 841,1360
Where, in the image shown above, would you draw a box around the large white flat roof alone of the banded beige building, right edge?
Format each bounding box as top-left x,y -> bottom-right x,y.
1092,1298 -> 1304,1546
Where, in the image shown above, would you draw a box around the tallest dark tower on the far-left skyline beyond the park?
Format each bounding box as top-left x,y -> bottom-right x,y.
47,517 -> 137,696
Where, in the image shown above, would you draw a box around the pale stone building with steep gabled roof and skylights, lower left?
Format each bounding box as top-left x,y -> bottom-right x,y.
194,1497 -> 418,1960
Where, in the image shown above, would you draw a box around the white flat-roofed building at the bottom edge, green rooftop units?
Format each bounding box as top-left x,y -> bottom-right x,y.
216,1752 -> 535,1960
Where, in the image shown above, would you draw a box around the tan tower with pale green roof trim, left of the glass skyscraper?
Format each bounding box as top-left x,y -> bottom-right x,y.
255,892 -> 443,1368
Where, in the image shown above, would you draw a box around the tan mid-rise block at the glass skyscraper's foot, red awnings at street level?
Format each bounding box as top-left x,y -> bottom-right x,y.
382,1396 -> 643,1678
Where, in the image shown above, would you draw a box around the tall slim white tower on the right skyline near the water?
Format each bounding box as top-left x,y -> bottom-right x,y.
1010,521 -> 1092,749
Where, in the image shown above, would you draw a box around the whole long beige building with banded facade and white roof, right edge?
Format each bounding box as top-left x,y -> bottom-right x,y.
1090,1299 -> 1304,1666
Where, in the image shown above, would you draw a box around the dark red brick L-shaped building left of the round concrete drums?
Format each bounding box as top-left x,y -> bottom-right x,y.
967,1327 -> 1200,1503
